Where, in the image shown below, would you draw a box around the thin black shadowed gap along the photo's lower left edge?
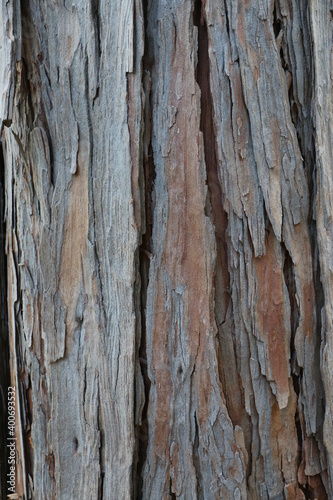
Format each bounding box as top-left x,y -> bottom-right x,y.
0,142 -> 10,498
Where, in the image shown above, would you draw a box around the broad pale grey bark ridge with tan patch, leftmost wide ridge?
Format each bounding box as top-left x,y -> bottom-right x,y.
5,0 -> 143,498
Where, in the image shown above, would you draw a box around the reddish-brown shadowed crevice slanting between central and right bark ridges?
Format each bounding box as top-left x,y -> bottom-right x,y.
193,0 -> 251,483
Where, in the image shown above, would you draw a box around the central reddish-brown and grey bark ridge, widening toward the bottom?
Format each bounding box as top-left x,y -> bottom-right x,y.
144,1 -> 246,498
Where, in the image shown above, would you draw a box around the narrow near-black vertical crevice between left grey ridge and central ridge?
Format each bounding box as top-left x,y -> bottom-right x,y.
135,0 -> 156,499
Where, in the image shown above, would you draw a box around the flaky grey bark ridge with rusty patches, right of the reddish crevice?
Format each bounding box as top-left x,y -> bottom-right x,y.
205,1 -> 325,495
